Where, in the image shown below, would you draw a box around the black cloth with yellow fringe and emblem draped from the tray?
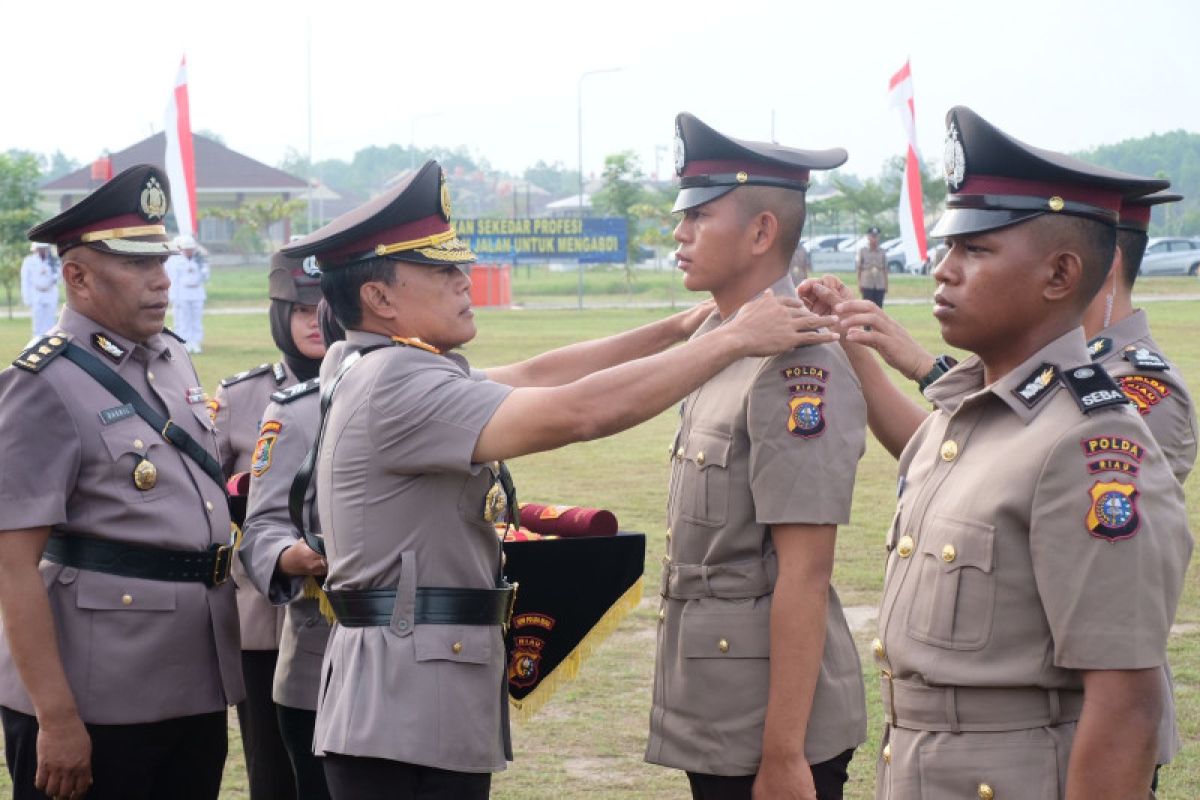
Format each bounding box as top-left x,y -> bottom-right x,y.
504,531 -> 646,718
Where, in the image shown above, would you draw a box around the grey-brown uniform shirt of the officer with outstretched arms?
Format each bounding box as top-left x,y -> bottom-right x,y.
314,331 -> 511,772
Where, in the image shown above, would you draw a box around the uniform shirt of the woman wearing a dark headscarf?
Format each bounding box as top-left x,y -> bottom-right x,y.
209,361 -> 296,650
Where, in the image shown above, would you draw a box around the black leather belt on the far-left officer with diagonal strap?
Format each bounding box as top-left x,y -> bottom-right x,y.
42,533 -> 234,587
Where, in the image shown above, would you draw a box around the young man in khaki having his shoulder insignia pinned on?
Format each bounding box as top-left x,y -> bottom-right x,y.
646,114 -> 866,800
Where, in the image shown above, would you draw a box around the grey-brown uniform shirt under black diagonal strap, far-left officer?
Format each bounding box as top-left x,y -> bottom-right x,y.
0,308 -> 244,724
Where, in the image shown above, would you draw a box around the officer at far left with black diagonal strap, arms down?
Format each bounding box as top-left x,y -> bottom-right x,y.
0,164 -> 242,800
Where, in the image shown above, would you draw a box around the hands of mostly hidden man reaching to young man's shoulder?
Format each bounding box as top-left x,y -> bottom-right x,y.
797,275 -> 934,380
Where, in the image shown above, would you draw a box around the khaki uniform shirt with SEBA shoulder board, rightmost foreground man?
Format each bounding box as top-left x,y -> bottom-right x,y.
874,329 -> 1192,800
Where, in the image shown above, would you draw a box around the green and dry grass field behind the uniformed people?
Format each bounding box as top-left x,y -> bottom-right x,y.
0,267 -> 1200,800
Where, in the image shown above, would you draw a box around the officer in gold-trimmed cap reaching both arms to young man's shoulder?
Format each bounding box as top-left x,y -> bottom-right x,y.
284,161 -> 834,800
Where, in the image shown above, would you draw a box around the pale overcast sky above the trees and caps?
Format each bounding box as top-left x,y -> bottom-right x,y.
0,0 -> 1200,183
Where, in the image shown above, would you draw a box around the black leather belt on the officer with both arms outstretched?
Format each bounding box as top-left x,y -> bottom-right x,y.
326,585 -> 516,627
